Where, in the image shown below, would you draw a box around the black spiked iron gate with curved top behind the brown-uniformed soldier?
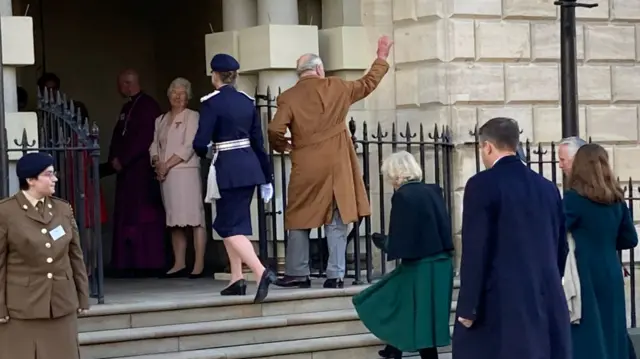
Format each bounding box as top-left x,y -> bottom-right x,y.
7,90 -> 104,304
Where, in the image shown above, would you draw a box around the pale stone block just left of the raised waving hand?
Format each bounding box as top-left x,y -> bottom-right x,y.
318,26 -> 371,71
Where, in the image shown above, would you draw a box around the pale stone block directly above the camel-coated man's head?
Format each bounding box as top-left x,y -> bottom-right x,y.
239,24 -> 318,72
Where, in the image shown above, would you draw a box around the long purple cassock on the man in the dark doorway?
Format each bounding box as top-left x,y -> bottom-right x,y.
109,92 -> 165,270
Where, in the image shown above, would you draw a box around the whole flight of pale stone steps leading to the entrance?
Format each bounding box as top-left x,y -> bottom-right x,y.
79,281 -> 459,359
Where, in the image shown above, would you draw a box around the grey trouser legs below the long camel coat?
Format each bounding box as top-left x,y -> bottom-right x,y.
284,207 -> 348,279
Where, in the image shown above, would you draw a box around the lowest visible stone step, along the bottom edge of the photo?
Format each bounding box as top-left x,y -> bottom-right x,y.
107,334 -> 451,359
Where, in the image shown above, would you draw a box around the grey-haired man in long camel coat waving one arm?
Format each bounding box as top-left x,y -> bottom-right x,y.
268,36 -> 393,288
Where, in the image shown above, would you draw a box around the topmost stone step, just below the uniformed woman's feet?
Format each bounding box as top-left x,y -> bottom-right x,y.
79,280 -> 459,333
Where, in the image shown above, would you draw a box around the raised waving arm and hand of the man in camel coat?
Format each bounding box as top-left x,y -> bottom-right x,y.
345,36 -> 393,103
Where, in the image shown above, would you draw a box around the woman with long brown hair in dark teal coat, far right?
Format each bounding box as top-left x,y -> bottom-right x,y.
564,144 -> 638,359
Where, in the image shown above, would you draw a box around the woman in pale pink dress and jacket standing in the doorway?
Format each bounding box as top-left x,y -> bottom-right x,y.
149,77 -> 206,278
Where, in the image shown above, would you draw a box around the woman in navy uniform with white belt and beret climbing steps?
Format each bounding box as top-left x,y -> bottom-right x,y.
193,54 -> 276,303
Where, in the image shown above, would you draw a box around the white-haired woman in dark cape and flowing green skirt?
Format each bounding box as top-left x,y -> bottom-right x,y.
353,151 -> 453,359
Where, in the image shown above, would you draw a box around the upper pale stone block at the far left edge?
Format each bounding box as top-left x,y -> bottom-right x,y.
0,16 -> 37,67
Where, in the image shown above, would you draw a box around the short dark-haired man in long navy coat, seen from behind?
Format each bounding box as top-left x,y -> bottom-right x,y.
453,118 -> 572,359
